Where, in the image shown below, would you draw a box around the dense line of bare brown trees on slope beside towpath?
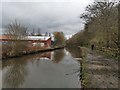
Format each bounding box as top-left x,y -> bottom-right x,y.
67,0 -> 120,57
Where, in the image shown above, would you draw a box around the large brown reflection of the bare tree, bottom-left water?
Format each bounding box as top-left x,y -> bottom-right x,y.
3,59 -> 27,88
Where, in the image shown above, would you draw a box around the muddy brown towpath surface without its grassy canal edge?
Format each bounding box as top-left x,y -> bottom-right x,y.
86,51 -> 118,88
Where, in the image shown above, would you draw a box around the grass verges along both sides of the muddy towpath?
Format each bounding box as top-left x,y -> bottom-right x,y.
80,47 -> 116,88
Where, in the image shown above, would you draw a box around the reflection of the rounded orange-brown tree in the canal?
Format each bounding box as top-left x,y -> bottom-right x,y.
53,49 -> 65,63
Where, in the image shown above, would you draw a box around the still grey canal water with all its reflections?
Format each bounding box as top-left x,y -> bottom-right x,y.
2,48 -> 81,88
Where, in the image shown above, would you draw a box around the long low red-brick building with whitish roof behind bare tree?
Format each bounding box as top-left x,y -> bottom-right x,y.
0,35 -> 51,48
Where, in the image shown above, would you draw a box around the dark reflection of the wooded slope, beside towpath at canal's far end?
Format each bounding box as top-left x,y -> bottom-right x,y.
66,46 -> 82,58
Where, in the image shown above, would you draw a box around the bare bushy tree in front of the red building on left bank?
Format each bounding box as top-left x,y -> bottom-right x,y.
6,20 -> 27,55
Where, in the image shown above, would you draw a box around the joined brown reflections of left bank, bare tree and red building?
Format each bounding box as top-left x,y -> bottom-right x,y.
2,52 -> 51,88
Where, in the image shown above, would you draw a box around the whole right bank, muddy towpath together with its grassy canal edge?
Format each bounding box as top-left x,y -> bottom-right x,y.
80,48 -> 118,88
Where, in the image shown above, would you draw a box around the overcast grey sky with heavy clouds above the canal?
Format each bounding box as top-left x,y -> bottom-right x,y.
0,0 -> 93,35
